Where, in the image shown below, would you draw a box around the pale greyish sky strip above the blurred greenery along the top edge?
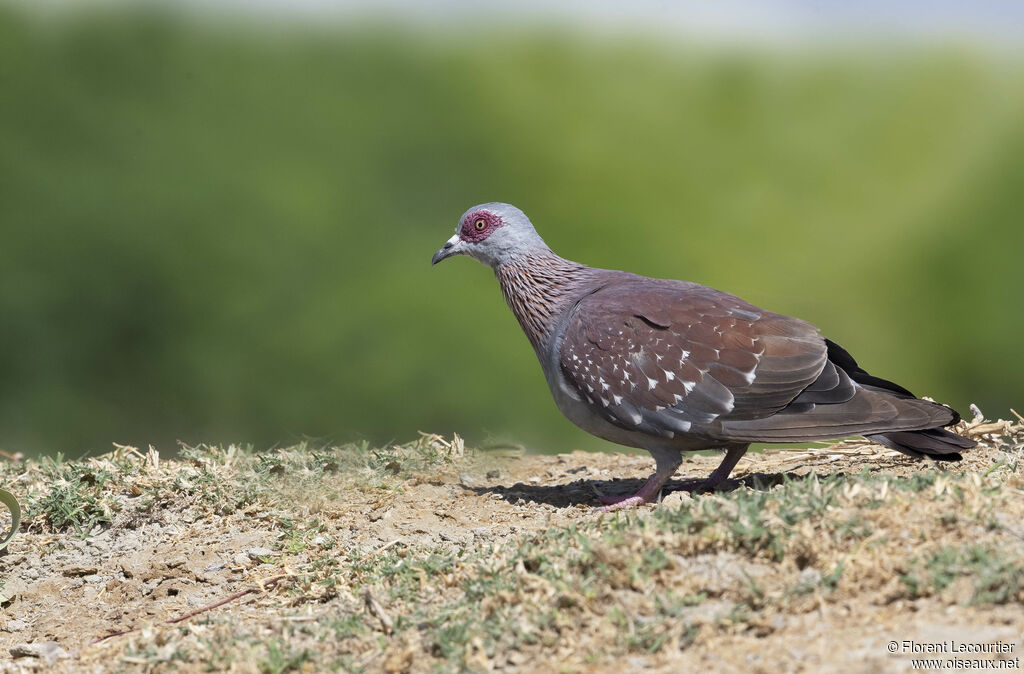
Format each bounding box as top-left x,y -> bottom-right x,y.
22,0 -> 1024,47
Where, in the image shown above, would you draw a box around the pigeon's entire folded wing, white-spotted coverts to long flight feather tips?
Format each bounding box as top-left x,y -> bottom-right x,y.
559,277 -> 942,441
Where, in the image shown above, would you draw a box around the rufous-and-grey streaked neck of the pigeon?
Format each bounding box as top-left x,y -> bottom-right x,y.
495,250 -> 593,354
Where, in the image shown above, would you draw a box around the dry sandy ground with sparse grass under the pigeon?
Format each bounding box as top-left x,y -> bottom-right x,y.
0,407 -> 1024,672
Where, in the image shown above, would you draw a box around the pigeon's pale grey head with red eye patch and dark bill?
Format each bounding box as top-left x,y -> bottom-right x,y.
431,202 -> 550,268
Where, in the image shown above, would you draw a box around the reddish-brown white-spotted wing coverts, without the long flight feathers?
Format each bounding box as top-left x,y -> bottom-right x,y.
561,282 -> 825,430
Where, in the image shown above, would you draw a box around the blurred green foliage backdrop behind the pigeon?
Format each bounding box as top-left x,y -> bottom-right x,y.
0,4 -> 1024,455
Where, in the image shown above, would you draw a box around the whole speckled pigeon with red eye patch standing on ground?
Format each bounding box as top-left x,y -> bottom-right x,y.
432,203 -> 975,508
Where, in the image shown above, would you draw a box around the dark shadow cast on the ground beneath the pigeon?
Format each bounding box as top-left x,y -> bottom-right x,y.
462,471 -> 842,508
